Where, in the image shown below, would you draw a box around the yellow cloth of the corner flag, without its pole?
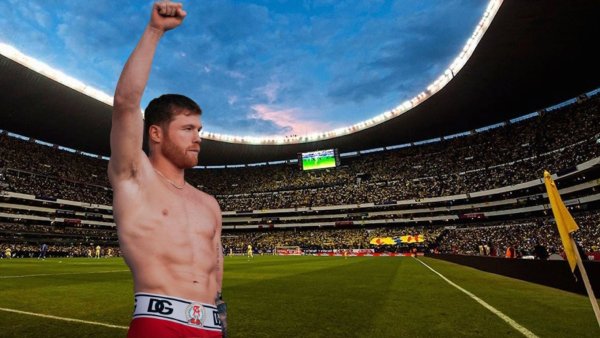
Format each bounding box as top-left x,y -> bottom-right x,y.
544,171 -> 579,272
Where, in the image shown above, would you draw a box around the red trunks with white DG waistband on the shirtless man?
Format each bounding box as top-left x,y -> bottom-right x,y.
127,293 -> 222,338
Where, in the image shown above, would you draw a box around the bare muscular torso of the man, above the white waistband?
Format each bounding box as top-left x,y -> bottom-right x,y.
113,158 -> 220,304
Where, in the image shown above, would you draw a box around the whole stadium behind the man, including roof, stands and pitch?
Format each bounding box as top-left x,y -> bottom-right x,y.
0,0 -> 600,337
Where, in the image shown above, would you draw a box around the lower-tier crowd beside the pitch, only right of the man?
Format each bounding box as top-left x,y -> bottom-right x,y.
218,211 -> 600,257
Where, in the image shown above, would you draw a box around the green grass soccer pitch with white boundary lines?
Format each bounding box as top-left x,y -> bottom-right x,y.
0,256 -> 600,338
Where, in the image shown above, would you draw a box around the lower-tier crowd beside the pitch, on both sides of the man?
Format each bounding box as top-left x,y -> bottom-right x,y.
0,210 -> 600,258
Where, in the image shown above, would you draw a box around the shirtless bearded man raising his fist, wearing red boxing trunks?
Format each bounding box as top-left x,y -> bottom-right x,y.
108,1 -> 227,338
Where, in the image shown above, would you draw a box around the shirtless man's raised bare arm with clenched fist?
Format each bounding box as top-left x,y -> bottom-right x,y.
108,1 -> 186,180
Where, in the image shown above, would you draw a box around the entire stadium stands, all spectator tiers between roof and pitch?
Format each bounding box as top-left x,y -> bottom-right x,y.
0,91 -> 600,256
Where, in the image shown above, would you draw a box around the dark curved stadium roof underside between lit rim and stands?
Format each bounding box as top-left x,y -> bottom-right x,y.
0,0 -> 600,165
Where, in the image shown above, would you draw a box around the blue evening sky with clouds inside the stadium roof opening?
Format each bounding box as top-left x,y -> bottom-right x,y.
0,0 -> 488,136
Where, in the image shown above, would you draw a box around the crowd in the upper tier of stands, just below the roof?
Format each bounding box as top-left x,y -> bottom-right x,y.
0,95 -> 600,210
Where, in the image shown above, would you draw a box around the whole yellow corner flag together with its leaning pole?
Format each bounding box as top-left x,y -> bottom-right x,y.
544,171 -> 600,326
